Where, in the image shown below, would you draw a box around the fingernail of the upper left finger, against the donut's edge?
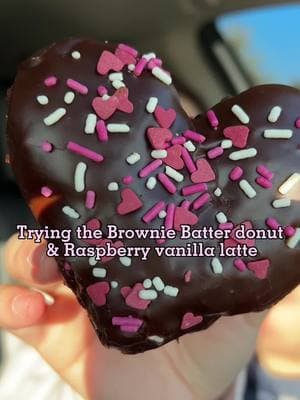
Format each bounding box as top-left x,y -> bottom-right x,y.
29,244 -> 61,284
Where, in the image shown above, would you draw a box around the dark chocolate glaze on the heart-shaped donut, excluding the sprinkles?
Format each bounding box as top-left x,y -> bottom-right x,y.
7,39 -> 300,353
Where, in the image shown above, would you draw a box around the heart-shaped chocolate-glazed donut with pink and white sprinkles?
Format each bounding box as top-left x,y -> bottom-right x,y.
7,39 -> 300,353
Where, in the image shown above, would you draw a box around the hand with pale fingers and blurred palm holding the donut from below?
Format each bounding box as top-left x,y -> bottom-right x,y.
0,236 -> 266,400
